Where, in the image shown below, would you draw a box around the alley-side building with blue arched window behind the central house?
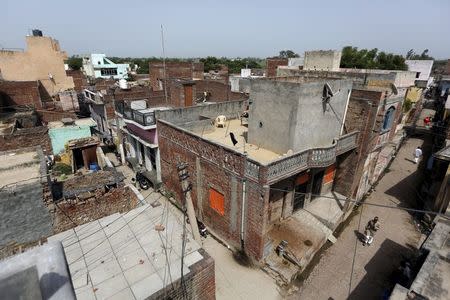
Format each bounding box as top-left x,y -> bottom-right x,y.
277,69 -> 416,200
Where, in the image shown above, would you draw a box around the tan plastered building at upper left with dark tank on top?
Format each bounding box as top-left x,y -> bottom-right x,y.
0,31 -> 74,98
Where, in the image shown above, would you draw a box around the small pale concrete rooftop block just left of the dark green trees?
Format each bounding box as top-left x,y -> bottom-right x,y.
303,50 -> 342,71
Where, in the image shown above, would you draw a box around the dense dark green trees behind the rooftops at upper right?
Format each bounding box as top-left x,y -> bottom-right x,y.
341,46 -> 408,70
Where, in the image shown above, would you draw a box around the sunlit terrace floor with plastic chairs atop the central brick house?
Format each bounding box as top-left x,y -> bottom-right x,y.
201,119 -> 282,164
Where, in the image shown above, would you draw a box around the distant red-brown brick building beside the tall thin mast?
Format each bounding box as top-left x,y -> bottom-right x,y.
149,61 -> 204,91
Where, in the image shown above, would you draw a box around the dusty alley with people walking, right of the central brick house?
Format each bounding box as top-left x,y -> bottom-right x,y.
290,138 -> 426,299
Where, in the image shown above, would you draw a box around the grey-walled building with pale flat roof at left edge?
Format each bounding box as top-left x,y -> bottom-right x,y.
0,147 -> 52,257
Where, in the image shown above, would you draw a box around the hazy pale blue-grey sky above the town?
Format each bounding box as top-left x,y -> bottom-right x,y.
0,0 -> 450,58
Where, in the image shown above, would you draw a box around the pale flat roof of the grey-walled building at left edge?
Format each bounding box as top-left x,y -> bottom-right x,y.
0,150 -> 41,188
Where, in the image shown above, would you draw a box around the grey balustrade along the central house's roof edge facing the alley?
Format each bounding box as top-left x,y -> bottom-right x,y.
264,132 -> 358,183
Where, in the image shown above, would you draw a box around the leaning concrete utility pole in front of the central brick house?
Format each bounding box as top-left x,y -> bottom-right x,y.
177,163 -> 202,244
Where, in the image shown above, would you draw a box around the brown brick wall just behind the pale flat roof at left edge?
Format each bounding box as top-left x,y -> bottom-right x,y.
0,126 -> 52,154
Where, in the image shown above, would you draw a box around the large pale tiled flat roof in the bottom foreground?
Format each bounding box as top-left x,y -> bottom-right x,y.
48,204 -> 204,300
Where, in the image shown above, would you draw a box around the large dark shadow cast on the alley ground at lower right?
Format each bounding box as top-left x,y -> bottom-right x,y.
348,236 -> 415,300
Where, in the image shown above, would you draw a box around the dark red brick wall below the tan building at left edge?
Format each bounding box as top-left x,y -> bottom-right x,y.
0,81 -> 42,108
